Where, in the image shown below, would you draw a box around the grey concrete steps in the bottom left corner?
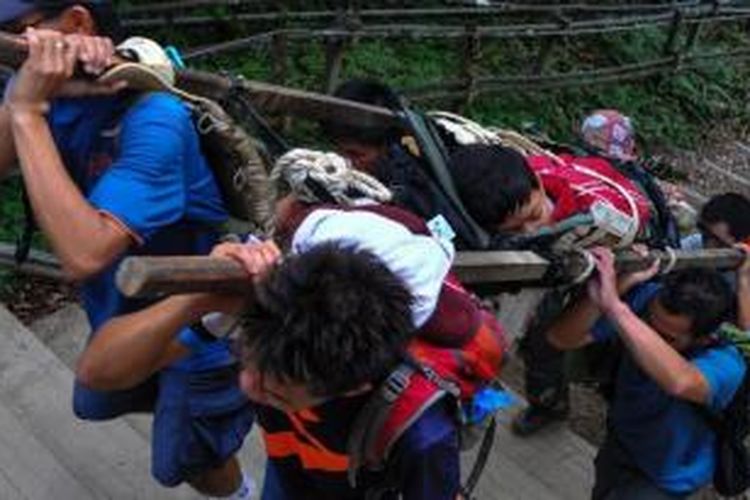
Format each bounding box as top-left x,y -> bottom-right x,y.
0,306 -> 197,499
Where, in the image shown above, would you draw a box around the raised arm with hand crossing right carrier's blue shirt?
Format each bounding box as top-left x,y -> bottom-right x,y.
589,250 -> 711,404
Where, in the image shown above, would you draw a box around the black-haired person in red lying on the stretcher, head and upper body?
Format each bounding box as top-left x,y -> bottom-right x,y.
450,144 -> 650,246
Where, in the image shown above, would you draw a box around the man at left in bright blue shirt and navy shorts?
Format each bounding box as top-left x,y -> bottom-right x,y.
0,0 -> 253,498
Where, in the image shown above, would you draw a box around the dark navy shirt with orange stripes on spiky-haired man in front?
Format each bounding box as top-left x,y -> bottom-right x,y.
256,393 -> 460,500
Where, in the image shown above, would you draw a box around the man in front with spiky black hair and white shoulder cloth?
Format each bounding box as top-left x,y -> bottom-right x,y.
80,213 -> 470,500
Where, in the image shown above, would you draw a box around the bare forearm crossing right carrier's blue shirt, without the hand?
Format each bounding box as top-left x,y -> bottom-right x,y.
607,302 -> 709,403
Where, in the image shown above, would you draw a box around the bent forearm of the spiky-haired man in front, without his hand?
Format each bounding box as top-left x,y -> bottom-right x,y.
77,295 -> 216,390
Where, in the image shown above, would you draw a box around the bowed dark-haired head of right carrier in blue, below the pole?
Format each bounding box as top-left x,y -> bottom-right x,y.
648,269 -> 734,352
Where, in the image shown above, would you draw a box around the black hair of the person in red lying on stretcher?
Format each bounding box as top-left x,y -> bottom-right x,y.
449,144 -> 540,231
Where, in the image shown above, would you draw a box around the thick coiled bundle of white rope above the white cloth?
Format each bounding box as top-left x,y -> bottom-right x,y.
271,149 -> 393,206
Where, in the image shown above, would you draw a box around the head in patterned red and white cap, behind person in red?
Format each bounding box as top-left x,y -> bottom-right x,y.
581,109 -> 636,161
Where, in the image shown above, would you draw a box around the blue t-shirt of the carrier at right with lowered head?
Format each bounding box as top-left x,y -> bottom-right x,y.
592,283 -> 745,494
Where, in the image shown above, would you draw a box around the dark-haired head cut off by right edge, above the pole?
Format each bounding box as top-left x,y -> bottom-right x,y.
698,193 -> 750,248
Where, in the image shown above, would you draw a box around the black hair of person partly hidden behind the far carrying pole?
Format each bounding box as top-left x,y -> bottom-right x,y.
323,79 -> 401,147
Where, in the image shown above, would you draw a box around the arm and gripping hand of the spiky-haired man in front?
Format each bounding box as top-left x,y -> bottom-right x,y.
76,241 -> 280,390
